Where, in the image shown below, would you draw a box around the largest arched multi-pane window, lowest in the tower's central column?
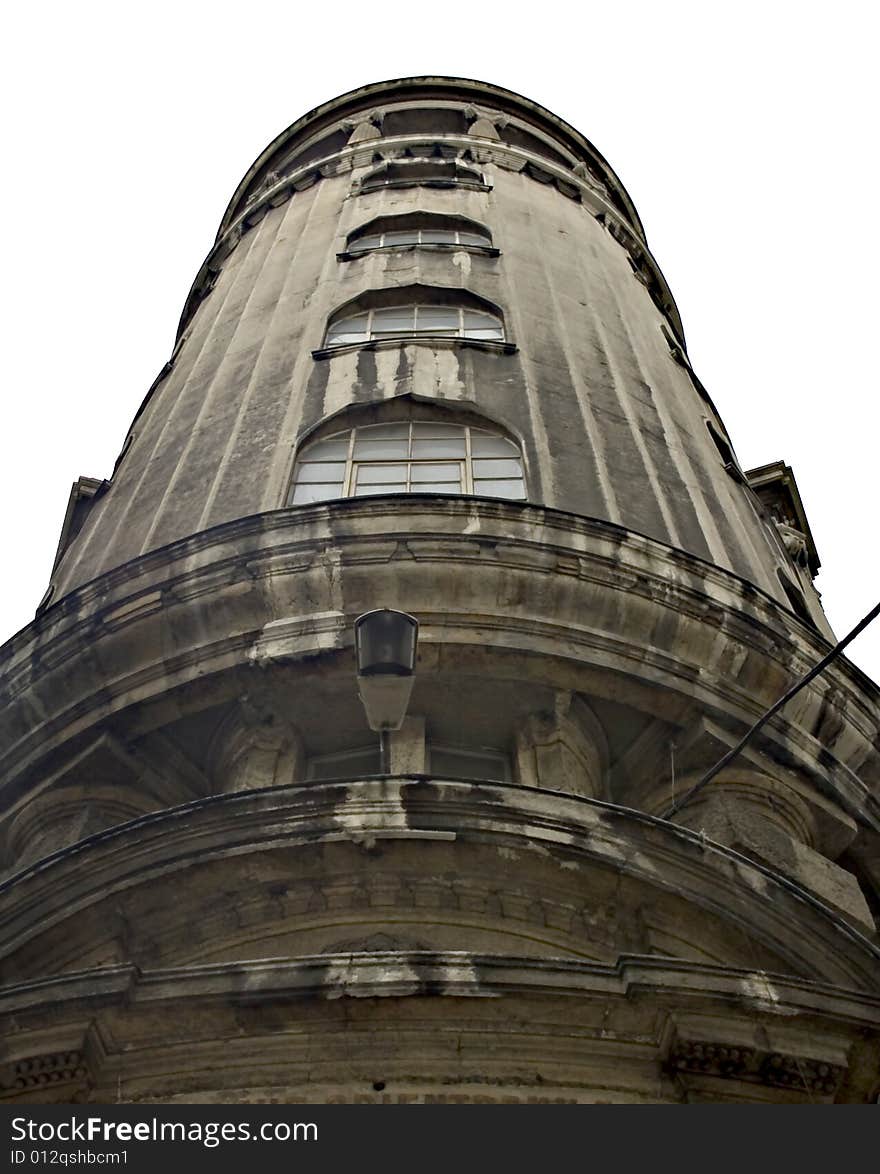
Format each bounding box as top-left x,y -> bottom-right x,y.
290,420 -> 526,505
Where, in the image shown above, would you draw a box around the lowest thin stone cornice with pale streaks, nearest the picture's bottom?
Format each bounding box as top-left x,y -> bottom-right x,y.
0,951 -> 880,1031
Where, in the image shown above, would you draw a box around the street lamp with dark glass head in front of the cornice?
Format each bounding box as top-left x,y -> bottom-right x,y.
354,607 -> 419,775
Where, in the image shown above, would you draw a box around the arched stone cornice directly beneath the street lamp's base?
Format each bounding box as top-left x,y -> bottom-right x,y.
0,776 -> 880,991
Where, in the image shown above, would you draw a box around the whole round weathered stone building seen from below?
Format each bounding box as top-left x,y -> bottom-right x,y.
0,77 -> 880,1104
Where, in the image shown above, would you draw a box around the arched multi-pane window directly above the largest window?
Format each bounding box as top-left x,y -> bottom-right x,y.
325,304 -> 505,346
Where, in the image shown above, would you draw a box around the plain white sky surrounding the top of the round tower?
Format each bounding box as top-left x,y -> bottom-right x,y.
0,0 -> 880,679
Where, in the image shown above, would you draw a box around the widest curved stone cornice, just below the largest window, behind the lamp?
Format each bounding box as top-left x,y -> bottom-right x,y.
0,494 -> 880,822
